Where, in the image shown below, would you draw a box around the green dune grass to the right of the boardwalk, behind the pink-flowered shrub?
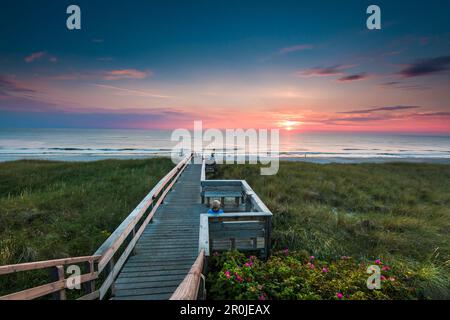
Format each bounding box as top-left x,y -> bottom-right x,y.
211,162 -> 450,299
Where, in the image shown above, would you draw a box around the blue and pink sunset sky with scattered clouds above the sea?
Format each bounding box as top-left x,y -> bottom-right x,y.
0,0 -> 450,133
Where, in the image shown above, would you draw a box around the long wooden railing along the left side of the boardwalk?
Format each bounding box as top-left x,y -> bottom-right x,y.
0,154 -> 192,300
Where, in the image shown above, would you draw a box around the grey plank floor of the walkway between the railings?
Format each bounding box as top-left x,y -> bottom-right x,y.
113,163 -> 206,300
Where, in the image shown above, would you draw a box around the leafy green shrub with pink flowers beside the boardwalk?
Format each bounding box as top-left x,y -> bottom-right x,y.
207,250 -> 418,300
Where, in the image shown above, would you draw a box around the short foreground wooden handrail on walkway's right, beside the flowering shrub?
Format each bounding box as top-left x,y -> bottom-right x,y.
170,250 -> 205,300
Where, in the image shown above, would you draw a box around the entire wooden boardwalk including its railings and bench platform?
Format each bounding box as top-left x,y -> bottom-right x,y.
0,153 -> 272,300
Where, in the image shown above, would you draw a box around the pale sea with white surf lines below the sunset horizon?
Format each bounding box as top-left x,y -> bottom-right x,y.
0,129 -> 450,163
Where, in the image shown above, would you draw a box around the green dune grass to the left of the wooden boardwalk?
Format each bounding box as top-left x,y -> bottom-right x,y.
0,159 -> 173,293
